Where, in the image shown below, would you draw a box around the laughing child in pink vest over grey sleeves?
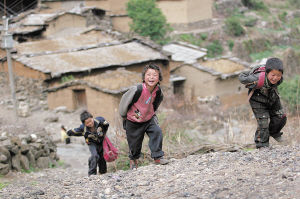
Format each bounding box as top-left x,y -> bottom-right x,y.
119,64 -> 168,169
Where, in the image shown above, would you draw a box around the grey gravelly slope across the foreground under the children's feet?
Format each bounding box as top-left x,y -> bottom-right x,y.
0,145 -> 300,199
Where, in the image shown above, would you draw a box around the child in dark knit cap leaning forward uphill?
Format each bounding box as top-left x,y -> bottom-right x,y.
239,58 -> 287,148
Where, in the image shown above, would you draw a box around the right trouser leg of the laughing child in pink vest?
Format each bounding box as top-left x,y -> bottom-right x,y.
146,117 -> 164,159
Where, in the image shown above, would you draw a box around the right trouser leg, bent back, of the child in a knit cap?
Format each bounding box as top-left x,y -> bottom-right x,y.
269,111 -> 287,138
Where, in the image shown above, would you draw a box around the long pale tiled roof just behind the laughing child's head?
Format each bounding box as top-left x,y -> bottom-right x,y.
13,41 -> 167,77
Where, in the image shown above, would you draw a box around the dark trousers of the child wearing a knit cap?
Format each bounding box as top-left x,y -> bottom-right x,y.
250,100 -> 287,148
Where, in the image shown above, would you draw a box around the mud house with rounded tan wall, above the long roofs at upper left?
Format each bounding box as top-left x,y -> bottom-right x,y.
10,7 -> 106,42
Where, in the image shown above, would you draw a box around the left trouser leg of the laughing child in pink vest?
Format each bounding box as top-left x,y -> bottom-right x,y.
126,120 -> 145,160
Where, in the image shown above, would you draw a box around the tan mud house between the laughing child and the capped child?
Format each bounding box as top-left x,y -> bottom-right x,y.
171,57 -> 249,105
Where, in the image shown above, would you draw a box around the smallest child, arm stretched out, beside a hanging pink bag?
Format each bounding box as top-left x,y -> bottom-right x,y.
67,111 -> 109,176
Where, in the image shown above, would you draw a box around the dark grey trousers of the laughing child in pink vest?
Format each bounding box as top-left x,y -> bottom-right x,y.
125,117 -> 164,160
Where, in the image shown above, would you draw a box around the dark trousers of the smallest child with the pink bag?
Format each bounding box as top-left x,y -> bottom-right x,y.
88,142 -> 107,175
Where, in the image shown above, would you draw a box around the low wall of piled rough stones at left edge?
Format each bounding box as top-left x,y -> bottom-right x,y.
0,132 -> 59,175
